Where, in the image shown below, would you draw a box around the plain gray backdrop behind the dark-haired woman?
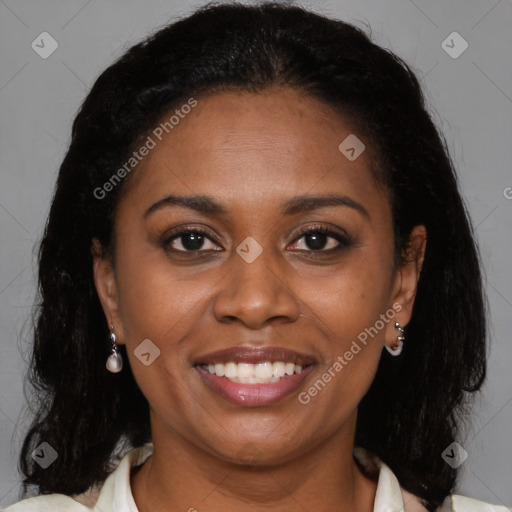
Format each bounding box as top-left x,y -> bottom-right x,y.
0,0 -> 512,508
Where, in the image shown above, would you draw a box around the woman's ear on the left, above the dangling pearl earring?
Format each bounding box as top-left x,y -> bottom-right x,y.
91,238 -> 124,345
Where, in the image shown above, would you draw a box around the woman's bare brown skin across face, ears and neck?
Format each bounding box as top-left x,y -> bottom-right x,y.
94,89 -> 426,512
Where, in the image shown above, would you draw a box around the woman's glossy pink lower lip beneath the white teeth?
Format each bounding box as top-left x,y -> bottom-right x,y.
195,364 -> 314,407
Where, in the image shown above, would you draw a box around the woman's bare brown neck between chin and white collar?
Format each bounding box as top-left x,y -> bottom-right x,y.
131,417 -> 377,512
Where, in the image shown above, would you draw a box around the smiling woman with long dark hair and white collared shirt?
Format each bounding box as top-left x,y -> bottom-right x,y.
6,4 -> 507,512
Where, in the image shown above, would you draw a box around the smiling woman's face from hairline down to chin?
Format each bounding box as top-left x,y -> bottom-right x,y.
95,89 -> 418,463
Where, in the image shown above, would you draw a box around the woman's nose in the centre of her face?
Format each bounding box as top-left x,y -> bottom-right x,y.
213,245 -> 301,329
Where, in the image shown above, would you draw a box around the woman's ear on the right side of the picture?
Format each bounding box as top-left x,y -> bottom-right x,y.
385,226 -> 427,348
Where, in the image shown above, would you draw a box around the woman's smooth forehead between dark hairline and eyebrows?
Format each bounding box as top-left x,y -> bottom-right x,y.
116,89 -> 385,220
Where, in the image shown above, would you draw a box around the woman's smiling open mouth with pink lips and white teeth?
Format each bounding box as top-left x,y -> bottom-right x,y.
194,347 -> 315,407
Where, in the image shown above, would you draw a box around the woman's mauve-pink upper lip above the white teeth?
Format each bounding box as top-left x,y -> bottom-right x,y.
195,345 -> 315,366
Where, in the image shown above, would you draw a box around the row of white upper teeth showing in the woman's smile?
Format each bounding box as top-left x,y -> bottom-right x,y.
202,361 -> 304,384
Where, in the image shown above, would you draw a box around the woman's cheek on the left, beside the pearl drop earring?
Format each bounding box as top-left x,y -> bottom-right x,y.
116,245 -> 203,412
